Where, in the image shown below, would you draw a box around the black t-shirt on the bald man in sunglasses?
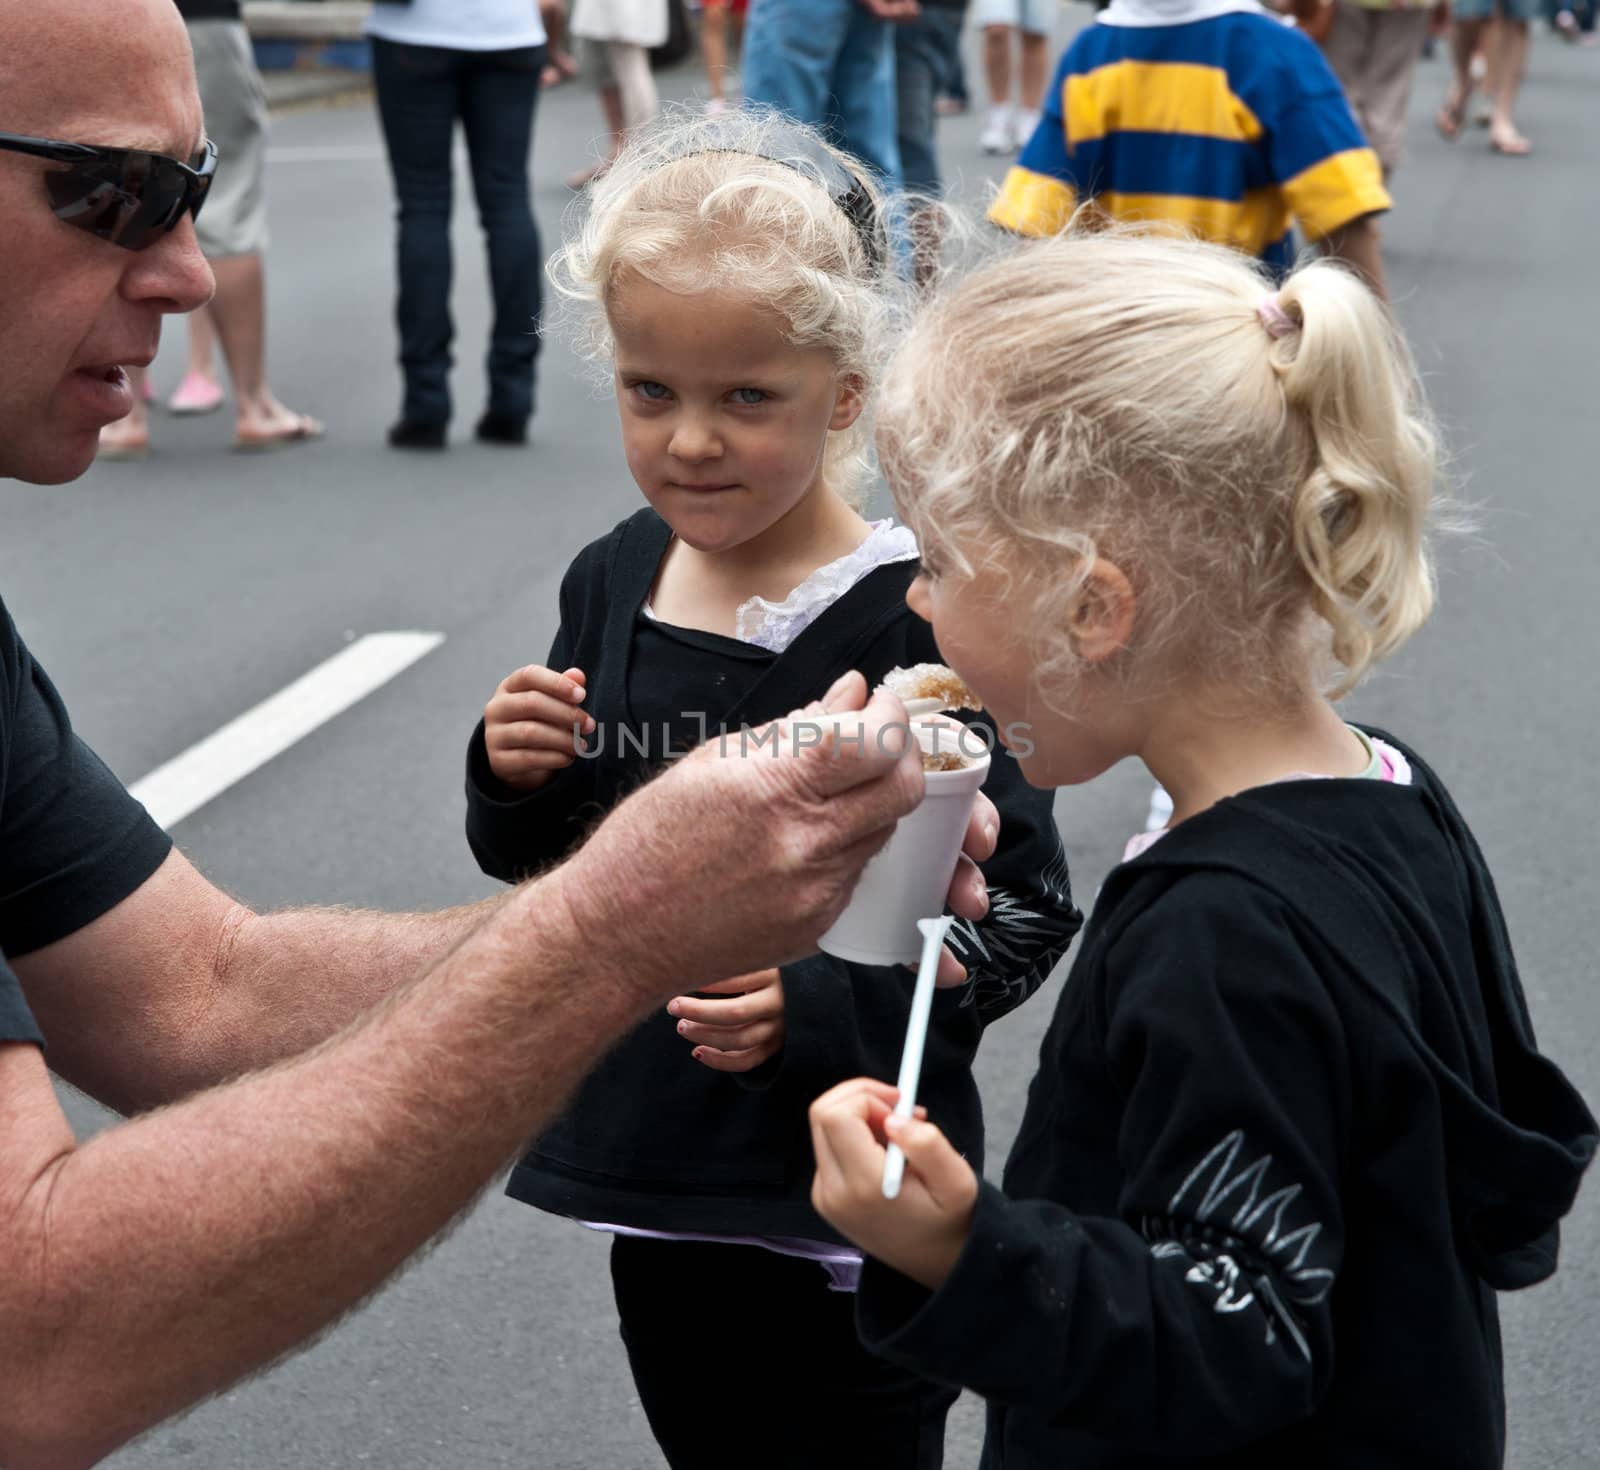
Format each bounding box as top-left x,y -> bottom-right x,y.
0,601 -> 171,1041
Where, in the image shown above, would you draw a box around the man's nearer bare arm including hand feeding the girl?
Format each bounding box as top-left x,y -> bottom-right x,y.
0,680 -> 934,1470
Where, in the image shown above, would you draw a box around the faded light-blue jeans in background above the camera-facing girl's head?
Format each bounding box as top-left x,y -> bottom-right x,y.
744,0 -> 901,190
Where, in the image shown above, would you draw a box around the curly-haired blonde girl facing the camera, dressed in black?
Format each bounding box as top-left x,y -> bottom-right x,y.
467,112 -> 1078,1470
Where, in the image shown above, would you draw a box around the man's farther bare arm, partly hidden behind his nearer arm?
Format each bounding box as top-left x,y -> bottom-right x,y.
13,848 -> 506,1113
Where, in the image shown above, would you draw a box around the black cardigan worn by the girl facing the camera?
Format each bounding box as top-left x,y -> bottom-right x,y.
467,510 -> 1080,1240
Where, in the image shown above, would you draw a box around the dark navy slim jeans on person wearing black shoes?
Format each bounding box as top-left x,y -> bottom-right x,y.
373,37 -> 546,424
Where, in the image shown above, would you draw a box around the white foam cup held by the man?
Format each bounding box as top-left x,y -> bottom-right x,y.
819,715 -> 990,965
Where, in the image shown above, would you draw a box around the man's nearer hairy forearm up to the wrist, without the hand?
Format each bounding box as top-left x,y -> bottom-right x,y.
0,873 -> 651,1470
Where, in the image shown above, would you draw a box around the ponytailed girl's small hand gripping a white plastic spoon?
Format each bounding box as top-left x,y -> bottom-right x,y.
811,1077 -> 978,1291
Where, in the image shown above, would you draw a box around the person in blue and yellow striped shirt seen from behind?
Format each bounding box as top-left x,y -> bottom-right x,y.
989,0 -> 1390,294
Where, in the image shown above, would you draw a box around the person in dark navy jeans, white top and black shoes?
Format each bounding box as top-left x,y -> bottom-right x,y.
366,0 -> 547,449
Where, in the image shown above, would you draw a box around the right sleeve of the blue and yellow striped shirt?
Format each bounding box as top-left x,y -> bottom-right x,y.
1267,37 -> 1394,240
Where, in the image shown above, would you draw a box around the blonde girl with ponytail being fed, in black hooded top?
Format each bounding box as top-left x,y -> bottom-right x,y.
811,230 -> 1597,1470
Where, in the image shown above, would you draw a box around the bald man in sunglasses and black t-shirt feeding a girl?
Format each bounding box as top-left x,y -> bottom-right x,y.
0,0 -> 994,1470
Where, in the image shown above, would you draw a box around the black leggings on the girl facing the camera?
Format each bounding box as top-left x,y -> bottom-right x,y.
611,1235 -> 957,1470
